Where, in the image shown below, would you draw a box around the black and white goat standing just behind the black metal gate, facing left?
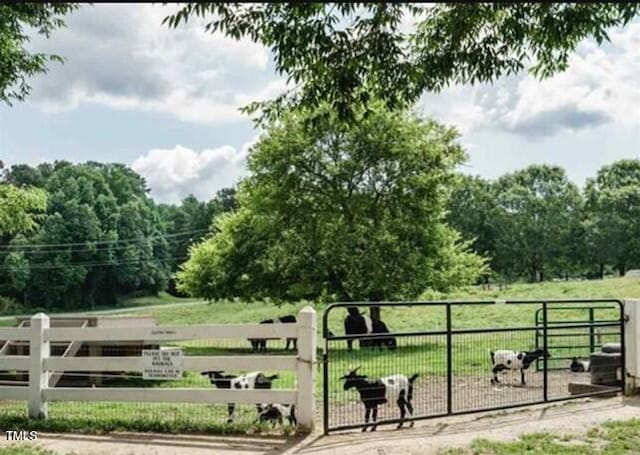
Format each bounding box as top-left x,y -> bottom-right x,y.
340,368 -> 418,431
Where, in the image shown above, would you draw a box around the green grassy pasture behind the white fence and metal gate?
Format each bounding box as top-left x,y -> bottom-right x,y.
0,279 -> 640,433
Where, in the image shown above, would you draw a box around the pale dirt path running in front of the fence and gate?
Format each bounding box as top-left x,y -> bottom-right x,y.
5,397 -> 640,455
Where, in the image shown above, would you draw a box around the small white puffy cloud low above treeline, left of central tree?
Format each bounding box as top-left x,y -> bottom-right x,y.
131,141 -> 254,203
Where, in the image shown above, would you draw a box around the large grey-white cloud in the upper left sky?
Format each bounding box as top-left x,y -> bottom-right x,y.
31,5 -> 285,124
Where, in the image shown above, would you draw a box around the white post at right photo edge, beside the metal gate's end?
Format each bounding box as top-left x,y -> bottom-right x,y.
622,300 -> 640,395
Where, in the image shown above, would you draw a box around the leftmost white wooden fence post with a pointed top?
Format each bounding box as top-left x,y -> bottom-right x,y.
29,313 -> 50,419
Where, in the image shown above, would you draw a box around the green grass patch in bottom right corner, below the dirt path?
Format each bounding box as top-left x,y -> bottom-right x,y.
440,419 -> 640,455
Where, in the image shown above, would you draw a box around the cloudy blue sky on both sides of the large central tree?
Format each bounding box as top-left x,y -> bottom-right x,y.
0,4 -> 640,202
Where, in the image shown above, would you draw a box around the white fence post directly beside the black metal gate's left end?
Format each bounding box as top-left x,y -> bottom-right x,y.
296,306 -> 317,431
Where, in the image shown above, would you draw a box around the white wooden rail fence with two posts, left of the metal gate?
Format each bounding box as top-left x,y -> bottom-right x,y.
0,307 -> 317,430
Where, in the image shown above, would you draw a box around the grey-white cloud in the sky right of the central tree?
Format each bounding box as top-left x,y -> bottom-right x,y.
419,20 -> 640,138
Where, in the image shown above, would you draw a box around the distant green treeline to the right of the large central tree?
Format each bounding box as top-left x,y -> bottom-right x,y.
447,159 -> 640,282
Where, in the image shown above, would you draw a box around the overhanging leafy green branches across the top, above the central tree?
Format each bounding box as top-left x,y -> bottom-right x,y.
164,2 -> 640,120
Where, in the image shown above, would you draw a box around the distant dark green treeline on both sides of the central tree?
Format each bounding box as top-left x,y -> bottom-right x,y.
0,160 -> 640,309
